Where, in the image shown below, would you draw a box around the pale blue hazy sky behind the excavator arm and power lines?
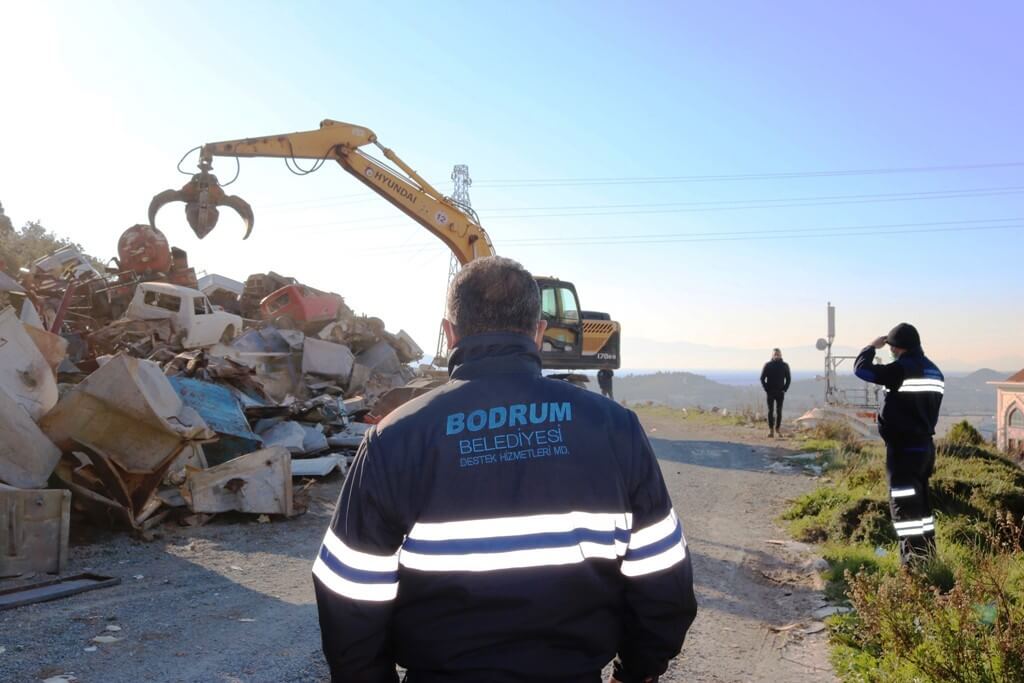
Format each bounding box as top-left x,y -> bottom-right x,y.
0,0 -> 1024,370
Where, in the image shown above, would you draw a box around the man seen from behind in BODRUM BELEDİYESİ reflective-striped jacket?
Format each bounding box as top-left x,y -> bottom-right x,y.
313,257 -> 696,683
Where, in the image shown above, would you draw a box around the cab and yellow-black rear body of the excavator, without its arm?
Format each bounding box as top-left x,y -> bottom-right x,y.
537,278 -> 620,370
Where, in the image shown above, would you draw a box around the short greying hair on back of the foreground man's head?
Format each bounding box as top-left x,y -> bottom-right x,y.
447,256 -> 541,338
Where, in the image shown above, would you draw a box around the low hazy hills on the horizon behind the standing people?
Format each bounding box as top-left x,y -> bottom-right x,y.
606,369 -> 1012,416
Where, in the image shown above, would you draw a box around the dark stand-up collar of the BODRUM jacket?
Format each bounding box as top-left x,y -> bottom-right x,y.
449,332 -> 541,380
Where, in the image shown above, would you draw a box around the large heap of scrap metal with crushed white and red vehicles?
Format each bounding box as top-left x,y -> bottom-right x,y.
0,225 -> 440,575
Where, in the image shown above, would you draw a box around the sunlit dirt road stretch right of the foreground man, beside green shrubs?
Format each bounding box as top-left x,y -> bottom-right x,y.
642,415 -> 836,683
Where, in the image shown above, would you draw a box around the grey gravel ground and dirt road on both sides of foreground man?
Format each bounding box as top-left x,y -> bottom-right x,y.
0,415 -> 833,683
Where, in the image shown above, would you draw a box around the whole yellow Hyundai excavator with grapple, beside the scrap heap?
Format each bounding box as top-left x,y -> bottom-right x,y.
150,119 -> 621,370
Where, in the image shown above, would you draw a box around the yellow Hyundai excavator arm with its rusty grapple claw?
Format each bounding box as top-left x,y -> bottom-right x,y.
150,119 -> 495,265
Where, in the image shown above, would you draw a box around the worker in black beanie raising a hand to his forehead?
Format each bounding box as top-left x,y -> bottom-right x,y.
854,323 -> 945,564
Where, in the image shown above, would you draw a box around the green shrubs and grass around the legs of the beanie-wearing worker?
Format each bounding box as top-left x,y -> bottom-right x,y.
782,438 -> 1024,683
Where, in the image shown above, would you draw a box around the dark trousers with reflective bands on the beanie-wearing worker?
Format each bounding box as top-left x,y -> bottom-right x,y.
886,442 -> 935,564
